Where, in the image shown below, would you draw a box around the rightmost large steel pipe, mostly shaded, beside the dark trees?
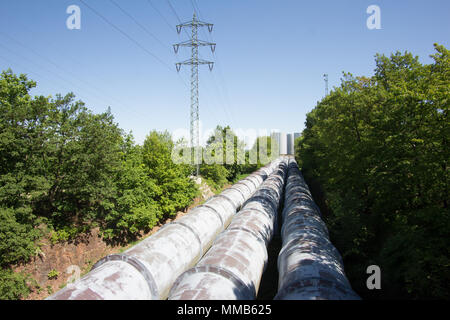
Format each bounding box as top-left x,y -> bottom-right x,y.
275,158 -> 360,300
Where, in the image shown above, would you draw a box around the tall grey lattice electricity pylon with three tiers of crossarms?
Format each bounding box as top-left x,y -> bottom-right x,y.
173,12 -> 216,176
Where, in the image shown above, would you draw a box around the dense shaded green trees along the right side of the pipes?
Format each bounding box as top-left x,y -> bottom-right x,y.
296,45 -> 450,299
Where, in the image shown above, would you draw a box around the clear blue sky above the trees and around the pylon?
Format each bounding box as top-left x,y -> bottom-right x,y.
0,0 -> 450,143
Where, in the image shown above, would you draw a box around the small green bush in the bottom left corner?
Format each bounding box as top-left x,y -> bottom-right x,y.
0,268 -> 30,300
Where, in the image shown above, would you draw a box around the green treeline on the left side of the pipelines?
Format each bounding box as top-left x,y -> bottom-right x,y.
0,70 -> 268,299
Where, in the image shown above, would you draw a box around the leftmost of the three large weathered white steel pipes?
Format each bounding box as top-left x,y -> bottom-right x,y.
47,159 -> 281,300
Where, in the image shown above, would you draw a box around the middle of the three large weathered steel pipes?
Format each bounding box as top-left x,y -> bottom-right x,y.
169,158 -> 288,300
